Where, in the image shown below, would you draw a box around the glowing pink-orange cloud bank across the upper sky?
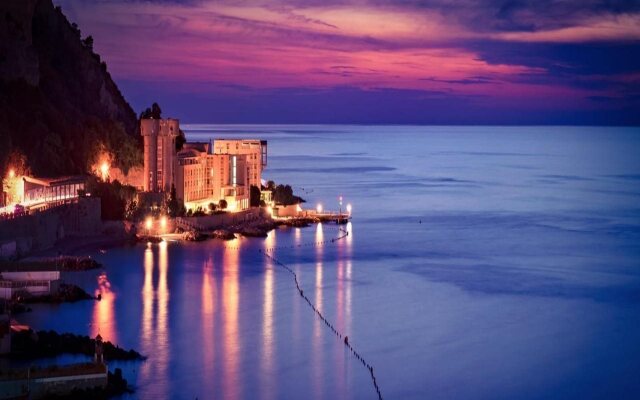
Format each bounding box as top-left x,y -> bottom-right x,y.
53,1 -> 624,104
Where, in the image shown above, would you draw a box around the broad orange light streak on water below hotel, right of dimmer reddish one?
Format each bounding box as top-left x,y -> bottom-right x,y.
222,240 -> 241,399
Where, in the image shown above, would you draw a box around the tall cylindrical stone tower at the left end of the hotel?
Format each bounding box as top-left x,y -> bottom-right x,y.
140,118 -> 180,192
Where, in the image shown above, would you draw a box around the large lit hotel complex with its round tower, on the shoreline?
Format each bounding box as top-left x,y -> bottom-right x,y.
140,119 -> 267,211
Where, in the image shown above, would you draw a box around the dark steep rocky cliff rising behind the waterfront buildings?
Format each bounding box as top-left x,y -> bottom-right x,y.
0,0 -> 141,176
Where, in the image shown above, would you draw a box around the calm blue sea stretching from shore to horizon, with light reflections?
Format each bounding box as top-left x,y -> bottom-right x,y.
19,125 -> 640,399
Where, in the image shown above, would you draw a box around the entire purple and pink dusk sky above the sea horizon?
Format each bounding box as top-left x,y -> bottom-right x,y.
54,0 -> 640,125
